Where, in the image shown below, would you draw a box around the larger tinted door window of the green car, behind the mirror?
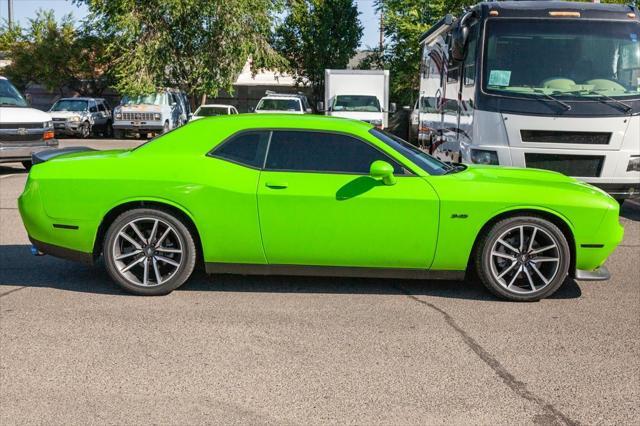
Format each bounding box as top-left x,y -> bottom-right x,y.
265,130 -> 406,175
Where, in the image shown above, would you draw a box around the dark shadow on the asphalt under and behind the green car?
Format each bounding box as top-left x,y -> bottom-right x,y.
0,245 -> 582,302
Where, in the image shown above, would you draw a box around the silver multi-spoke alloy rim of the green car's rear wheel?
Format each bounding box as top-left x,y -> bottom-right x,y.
111,217 -> 185,287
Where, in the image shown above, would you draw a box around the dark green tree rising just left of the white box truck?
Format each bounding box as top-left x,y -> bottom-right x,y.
273,0 -> 363,100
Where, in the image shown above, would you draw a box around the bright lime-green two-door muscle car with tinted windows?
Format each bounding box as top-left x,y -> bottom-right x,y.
19,115 -> 623,301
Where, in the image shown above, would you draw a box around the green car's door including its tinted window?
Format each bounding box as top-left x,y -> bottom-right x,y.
258,130 -> 439,269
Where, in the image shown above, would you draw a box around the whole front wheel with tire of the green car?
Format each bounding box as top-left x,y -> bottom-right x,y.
475,216 -> 571,302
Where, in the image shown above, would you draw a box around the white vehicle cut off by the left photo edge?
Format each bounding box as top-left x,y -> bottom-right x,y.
0,76 -> 58,170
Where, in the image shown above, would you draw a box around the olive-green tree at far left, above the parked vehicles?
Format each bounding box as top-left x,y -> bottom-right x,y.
0,10 -> 116,95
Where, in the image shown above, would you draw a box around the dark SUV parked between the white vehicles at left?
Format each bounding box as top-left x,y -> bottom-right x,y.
49,97 -> 113,138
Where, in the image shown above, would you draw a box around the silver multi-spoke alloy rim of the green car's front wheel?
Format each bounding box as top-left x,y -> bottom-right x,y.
490,225 -> 562,294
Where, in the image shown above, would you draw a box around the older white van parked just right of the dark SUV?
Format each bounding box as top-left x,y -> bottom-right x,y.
113,90 -> 189,138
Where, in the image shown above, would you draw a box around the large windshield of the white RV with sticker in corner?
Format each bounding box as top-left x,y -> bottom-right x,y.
483,18 -> 640,101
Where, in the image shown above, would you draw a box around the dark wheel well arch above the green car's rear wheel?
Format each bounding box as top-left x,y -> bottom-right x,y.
93,201 -> 203,262
